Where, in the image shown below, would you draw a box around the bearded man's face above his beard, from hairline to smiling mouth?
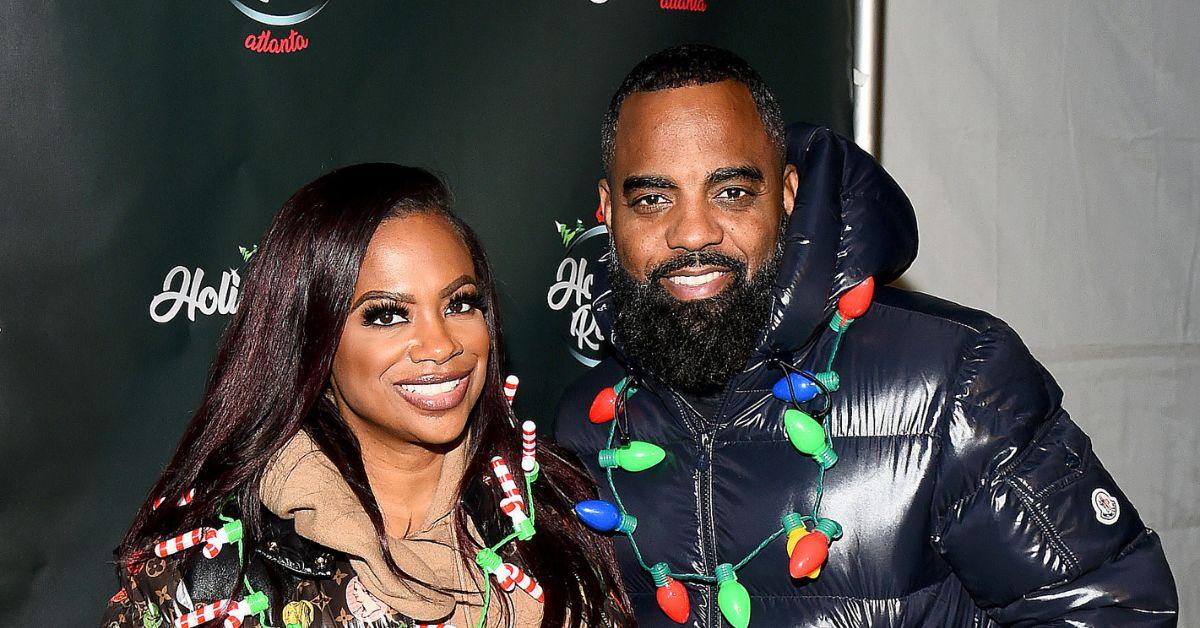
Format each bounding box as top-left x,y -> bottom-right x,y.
600,80 -> 797,301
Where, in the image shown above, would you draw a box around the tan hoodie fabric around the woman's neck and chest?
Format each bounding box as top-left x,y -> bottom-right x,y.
259,431 -> 541,627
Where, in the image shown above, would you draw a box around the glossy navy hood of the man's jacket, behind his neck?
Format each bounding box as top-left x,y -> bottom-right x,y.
593,122 -> 917,358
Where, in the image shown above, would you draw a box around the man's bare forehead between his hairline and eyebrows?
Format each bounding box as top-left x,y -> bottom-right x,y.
613,80 -> 774,172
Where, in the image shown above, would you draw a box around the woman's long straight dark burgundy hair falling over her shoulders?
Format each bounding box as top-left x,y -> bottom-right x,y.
118,163 -> 634,628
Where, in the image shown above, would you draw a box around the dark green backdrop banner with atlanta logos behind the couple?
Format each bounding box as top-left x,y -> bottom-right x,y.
0,0 -> 852,626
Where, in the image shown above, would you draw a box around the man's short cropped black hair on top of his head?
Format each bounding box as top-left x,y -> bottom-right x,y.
600,43 -> 787,174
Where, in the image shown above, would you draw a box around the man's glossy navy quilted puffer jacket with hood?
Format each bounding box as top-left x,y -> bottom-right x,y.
556,125 -> 1177,628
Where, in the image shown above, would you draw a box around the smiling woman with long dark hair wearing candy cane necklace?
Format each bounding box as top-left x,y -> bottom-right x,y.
103,163 -> 632,628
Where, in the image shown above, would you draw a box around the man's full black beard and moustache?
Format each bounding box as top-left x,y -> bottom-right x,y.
608,226 -> 786,395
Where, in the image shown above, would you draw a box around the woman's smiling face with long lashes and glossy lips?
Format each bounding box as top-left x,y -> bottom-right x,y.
331,214 -> 488,445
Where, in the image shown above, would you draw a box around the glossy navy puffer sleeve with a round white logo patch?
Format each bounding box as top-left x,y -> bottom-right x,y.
931,322 -> 1178,627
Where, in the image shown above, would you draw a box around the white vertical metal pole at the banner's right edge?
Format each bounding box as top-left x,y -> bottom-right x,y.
853,0 -> 883,157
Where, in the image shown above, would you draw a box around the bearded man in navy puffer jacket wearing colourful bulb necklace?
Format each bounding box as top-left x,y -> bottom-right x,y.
557,46 -> 1177,628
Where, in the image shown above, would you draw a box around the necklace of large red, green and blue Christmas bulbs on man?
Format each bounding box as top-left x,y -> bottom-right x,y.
575,277 -> 875,628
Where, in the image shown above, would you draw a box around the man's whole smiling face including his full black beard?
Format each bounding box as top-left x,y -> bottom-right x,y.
600,80 -> 797,394
